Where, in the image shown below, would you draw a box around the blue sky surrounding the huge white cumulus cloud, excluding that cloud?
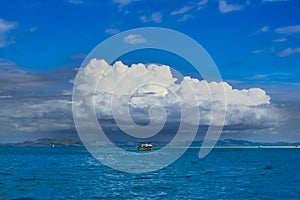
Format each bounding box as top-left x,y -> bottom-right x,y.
0,0 -> 300,141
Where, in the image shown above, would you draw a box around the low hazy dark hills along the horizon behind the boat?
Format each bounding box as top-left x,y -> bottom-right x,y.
0,138 -> 300,147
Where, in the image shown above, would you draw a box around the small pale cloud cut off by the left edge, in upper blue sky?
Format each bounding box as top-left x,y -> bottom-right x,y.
0,18 -> 17,47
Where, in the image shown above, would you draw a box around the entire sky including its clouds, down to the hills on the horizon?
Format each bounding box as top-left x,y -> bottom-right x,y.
0,0 -> 300,143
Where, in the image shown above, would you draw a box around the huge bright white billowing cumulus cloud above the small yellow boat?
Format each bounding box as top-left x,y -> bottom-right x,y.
75,59 -> 278,127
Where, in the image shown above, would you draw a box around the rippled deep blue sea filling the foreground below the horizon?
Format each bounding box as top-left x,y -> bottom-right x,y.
0,147 -> 300,199
